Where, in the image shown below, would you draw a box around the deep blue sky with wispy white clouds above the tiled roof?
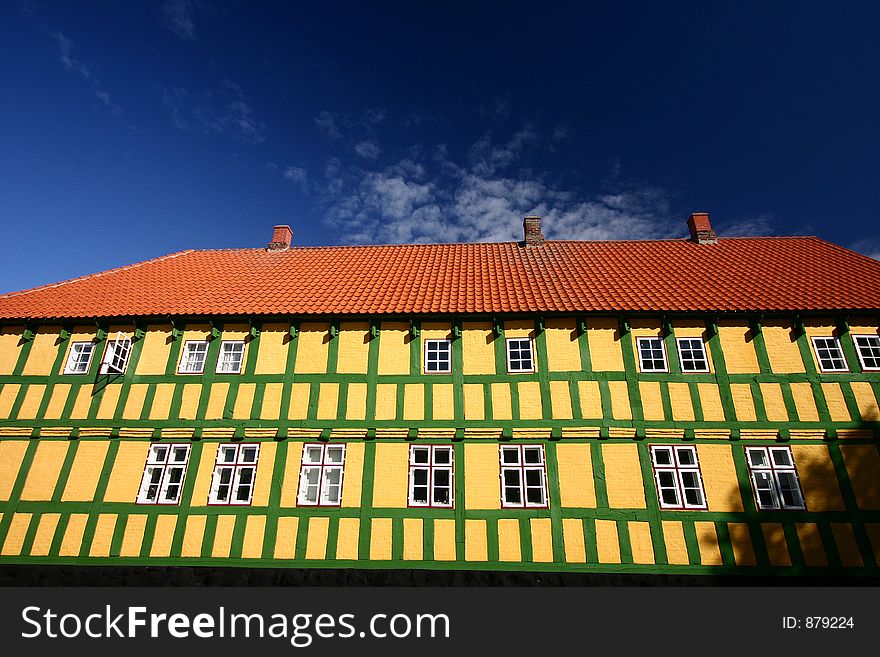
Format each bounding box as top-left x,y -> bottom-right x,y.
0,0 -> 880,292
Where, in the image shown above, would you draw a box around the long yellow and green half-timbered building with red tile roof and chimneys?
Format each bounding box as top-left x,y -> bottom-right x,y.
0,214 -> 880,575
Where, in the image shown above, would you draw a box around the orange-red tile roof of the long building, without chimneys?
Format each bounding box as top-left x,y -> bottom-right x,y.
0,237 -> 880,319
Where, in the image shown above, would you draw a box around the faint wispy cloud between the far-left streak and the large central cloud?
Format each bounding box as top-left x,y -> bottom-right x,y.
158,80 -> 266,144
